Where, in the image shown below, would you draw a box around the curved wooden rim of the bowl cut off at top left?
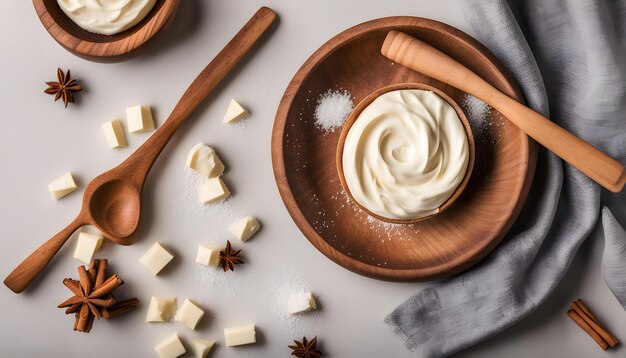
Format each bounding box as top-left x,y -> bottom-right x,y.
33,0 -> 180,59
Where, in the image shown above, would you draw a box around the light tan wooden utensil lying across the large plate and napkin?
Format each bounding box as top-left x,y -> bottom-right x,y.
381,31 -> 626,193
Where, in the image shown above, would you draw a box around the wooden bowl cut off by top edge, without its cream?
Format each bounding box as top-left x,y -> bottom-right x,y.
33,0 -> 180,62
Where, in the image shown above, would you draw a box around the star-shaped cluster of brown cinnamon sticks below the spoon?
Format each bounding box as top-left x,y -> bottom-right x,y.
58,260 -> 139,333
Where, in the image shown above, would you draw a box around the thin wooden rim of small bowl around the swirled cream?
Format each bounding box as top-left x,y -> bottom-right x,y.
336,83 -> 476,224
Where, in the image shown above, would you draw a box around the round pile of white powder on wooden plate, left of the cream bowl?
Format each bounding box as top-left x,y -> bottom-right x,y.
314,90 -> 354,132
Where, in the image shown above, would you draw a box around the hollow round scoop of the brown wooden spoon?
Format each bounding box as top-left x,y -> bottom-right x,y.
88,179 -> 141,245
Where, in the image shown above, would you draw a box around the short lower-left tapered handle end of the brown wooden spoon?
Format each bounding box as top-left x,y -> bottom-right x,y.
4,216 -> 83,293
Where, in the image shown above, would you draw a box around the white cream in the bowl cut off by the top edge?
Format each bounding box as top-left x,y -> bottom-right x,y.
57,0 -> 156,35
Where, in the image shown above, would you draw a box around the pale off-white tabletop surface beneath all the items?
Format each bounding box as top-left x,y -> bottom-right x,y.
0,0 -> 626,357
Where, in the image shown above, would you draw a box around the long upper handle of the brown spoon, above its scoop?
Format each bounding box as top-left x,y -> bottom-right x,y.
120,7 -> 276,186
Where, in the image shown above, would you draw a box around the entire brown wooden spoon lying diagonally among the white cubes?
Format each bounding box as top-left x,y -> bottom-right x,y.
4,7 -> 276,293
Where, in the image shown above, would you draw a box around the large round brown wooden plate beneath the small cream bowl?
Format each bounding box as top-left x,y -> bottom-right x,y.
272,17 -> 536,281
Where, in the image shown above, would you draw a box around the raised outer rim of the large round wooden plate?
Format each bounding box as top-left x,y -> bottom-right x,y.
271,16 -> 537,282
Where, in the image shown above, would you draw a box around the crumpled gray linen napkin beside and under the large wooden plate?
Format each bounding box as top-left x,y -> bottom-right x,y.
385,0 -> 626,357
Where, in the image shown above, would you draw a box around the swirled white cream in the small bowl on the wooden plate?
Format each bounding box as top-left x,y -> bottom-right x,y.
342,90 -> 469,220
